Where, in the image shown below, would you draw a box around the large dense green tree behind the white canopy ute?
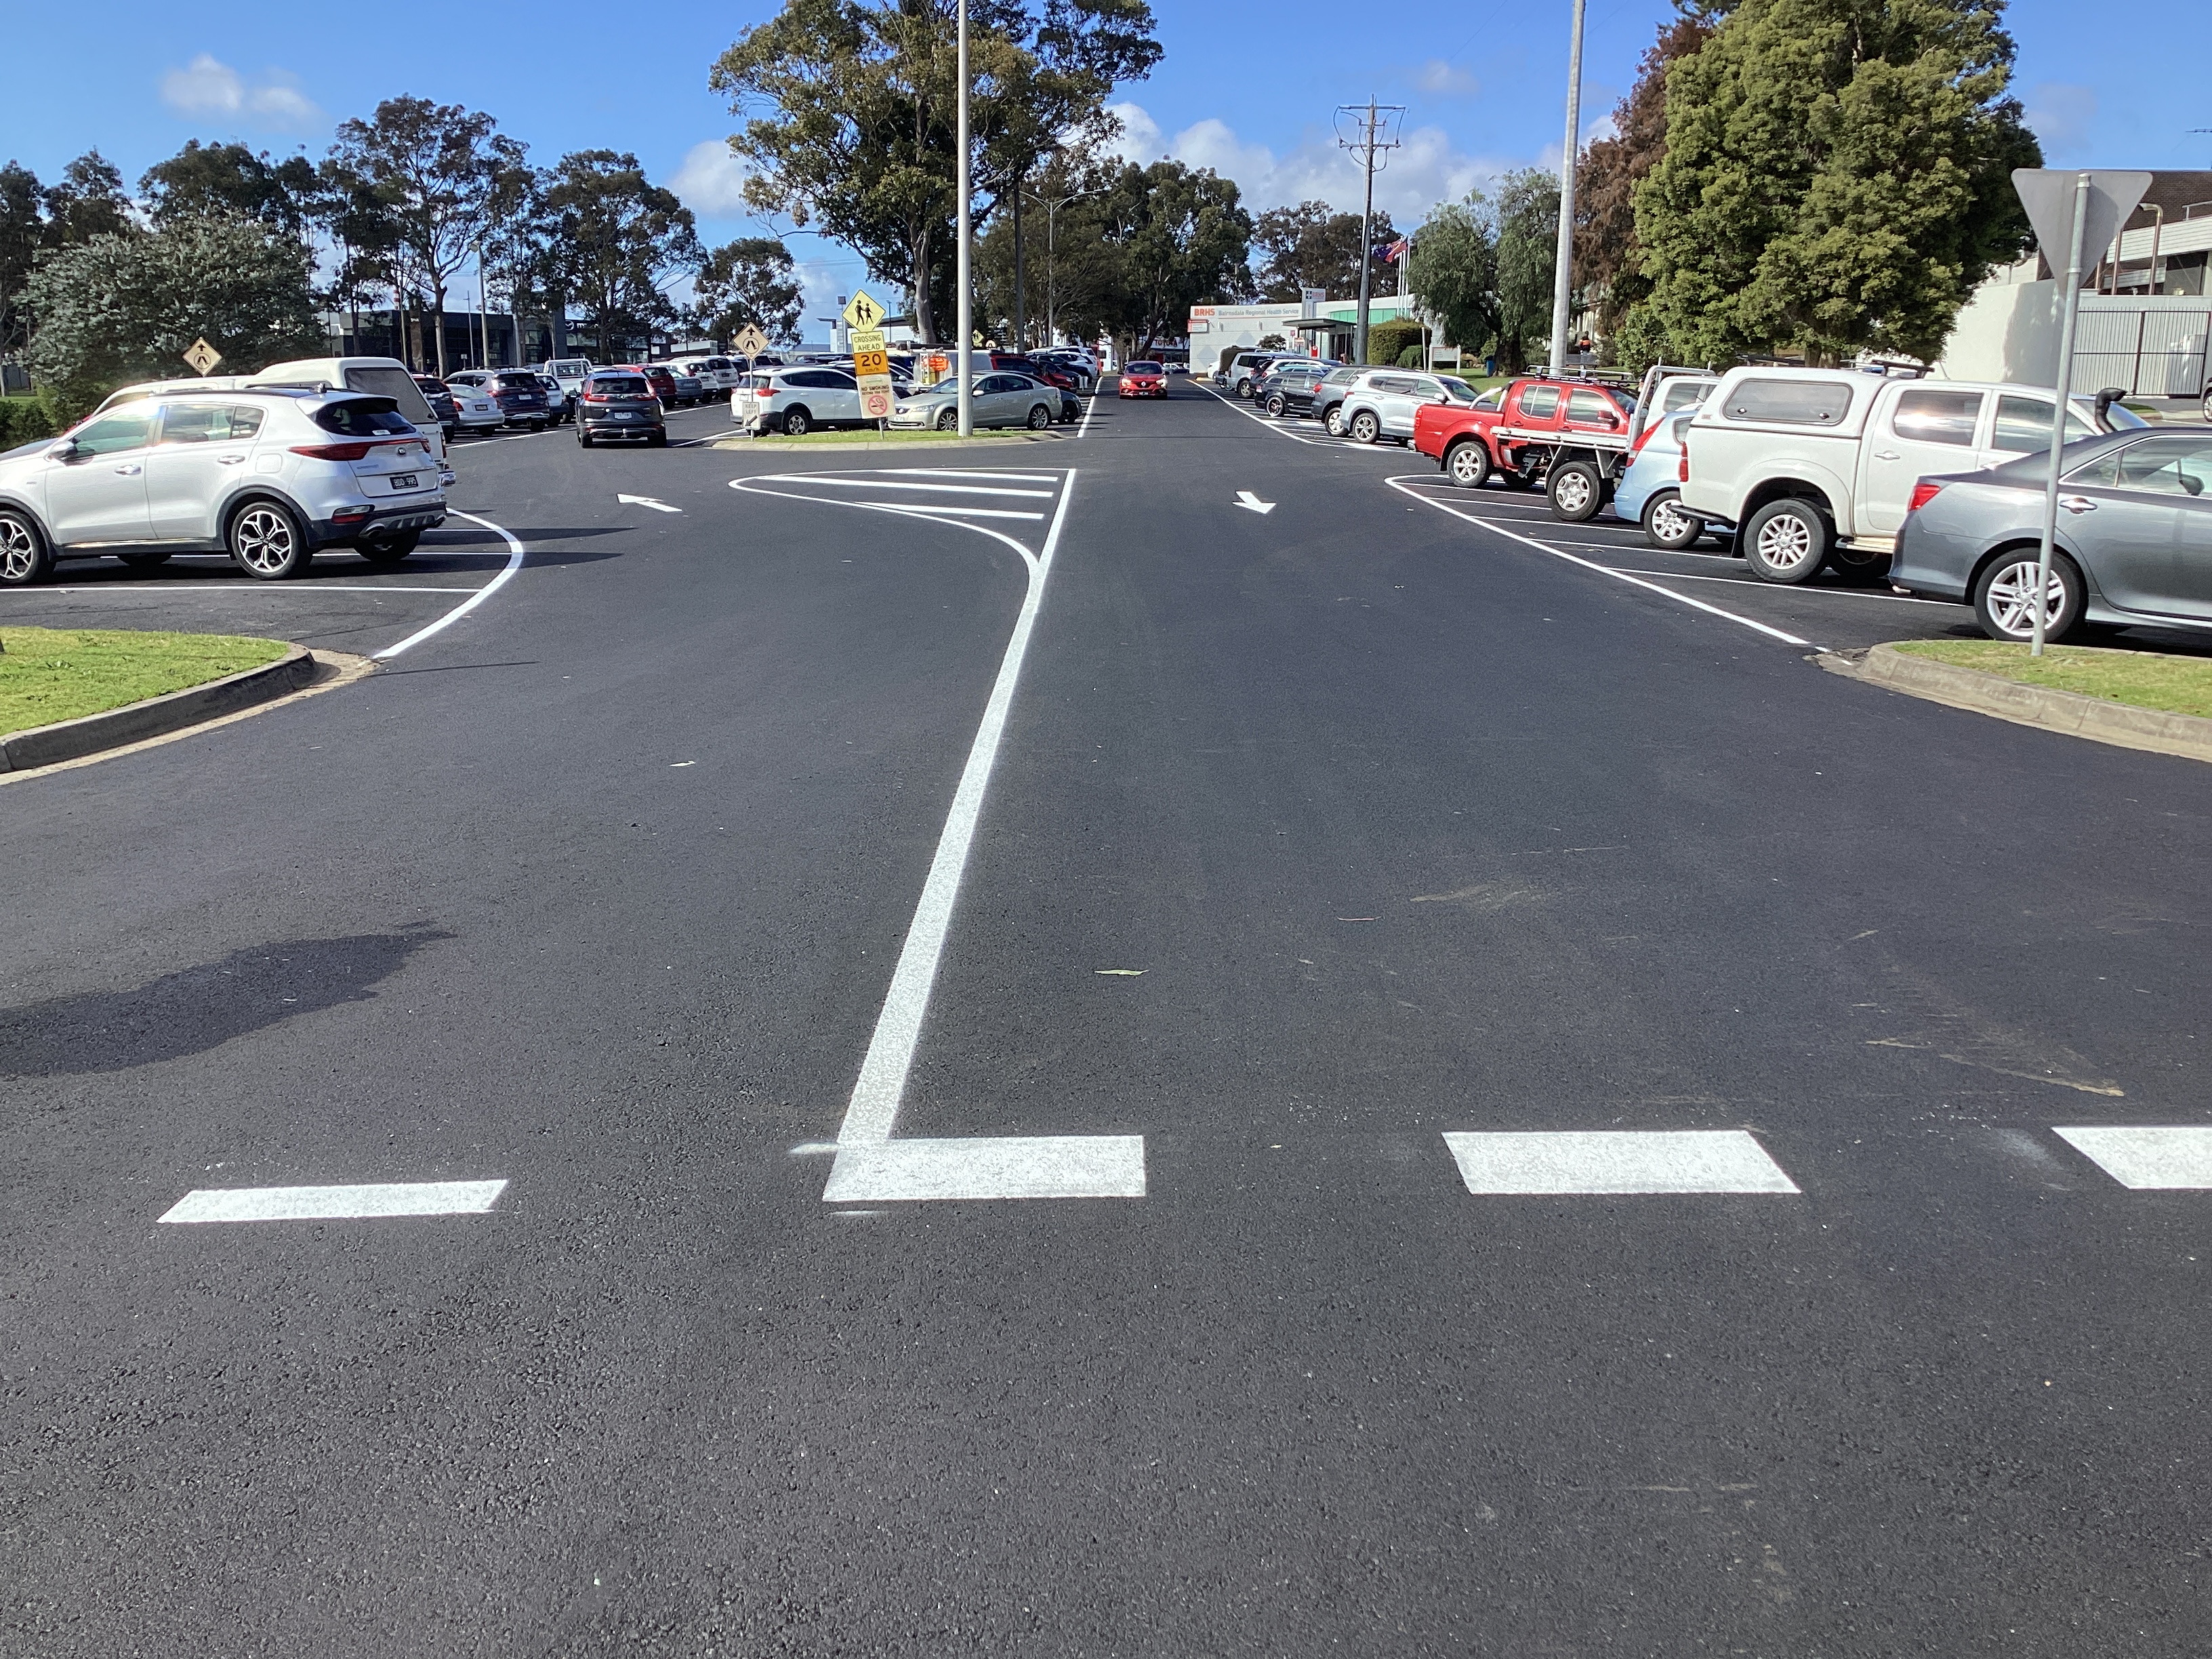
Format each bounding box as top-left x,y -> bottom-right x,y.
1635,0 -> 2042,361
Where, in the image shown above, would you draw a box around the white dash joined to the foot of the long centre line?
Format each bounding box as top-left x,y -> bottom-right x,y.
823,1134 -> 1143,1204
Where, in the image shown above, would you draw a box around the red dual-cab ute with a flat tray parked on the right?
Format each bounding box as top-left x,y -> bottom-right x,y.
1414,374 -> 1631,525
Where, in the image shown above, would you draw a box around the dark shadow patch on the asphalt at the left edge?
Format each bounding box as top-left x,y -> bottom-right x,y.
0,927 -> 453,1078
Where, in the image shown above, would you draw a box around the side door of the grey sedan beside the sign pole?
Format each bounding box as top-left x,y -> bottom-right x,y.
2060,431 -> 2212,619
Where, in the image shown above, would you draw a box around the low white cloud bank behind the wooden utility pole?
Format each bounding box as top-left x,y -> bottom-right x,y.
1111,104 -> 1513,228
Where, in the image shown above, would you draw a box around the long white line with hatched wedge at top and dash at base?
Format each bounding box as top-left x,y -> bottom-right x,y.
730,467 -> 1143,1204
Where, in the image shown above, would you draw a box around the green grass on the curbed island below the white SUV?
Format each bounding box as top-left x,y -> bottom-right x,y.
0,628 -> 290,732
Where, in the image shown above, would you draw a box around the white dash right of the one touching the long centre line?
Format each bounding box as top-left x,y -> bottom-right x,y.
1444,1128 -> 1799,1195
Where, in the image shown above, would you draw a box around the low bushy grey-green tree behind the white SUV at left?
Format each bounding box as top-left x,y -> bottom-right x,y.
26,215 -> 321,401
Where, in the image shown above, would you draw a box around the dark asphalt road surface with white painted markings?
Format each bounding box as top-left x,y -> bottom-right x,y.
0,385 -> 2212,1659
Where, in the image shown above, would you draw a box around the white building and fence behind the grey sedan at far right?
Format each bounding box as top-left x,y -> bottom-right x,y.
1933,173 -> 2212,398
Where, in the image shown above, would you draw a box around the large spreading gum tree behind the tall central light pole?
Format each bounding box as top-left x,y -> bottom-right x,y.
710,0 -> 1159,338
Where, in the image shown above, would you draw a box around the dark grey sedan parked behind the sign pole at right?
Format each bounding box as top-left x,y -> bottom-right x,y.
1889,429 -> 2212,639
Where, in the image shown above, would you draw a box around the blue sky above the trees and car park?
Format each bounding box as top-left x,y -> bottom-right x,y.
0,0 -> 2212,316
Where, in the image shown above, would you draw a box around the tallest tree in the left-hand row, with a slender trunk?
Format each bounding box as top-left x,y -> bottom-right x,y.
327,98 -> 529,374
